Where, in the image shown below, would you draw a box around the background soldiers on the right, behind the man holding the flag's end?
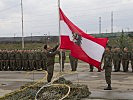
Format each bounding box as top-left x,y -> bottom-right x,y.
90,47 -> 133,72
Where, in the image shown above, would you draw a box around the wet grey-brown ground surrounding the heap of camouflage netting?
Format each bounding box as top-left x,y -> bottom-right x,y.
0,63 -> 133,100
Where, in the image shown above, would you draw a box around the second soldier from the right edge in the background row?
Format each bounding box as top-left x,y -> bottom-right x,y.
122,47 -> 131,72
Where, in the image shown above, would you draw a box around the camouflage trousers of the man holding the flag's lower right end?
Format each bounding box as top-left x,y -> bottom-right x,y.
105,66 -> 112,84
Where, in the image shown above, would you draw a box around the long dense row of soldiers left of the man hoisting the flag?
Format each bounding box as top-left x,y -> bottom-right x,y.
0,50 -> 46,71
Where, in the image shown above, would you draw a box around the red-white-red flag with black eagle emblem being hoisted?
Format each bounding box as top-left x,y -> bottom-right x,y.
59,9 -> 108,69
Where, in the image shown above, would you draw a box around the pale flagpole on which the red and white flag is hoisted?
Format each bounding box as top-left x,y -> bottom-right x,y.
58,0 -> 62,72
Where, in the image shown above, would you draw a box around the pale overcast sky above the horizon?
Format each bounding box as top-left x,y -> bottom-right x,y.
0,0 -> 133,37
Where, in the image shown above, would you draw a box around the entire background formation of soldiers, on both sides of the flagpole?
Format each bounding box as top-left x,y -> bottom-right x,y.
0,47 -> 133,72
